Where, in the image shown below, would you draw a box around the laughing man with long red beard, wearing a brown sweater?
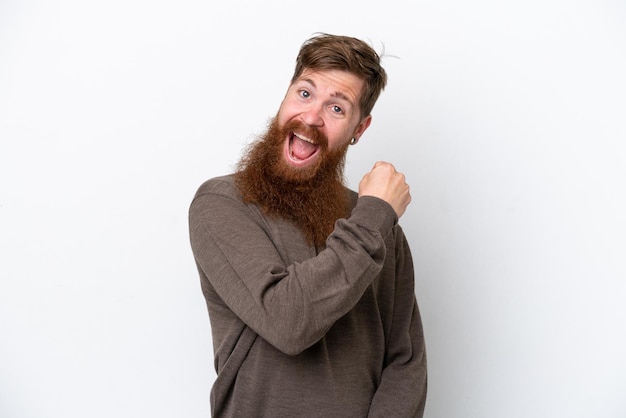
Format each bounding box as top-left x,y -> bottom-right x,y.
189,34 -> 427,418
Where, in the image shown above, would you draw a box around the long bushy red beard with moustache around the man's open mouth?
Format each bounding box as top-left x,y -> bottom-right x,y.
235,118 -> 350,247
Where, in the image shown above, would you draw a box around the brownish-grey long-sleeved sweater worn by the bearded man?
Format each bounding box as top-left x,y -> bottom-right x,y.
189,176 -> 427,418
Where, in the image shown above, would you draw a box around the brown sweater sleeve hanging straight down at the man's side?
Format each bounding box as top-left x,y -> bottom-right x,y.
368,230 -> 427,418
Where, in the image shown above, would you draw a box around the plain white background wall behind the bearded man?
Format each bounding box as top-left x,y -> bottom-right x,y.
0,0 -> 626,418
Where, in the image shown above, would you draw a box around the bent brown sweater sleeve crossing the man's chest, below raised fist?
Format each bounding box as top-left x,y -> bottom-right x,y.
189,176 -> 397,355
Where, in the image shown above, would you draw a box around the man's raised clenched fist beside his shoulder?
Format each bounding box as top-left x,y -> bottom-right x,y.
359,161 -> 411,218
